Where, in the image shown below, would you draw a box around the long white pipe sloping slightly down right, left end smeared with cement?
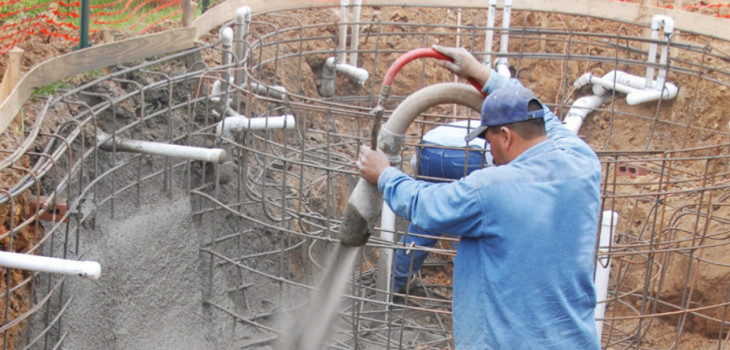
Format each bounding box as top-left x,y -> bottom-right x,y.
96,133 -> 226,163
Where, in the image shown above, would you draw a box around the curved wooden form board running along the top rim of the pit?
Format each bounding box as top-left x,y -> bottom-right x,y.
0,0 -> 730,134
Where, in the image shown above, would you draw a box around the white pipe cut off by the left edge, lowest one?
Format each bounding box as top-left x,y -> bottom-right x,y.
0,251 -> 101,280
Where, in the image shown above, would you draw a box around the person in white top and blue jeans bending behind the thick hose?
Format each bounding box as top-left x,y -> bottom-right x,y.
393,120 -> 492,292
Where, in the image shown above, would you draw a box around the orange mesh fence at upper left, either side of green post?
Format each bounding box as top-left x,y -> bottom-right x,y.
0,0 -> 188,55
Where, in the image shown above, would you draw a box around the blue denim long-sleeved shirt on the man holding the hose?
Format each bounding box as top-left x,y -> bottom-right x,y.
378,72 -> 601,349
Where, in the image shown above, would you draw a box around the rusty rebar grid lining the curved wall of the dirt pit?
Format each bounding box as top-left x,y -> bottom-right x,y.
0,6 -> 730,349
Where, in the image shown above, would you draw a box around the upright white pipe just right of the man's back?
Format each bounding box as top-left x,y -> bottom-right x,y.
594,210 -> 618,343
